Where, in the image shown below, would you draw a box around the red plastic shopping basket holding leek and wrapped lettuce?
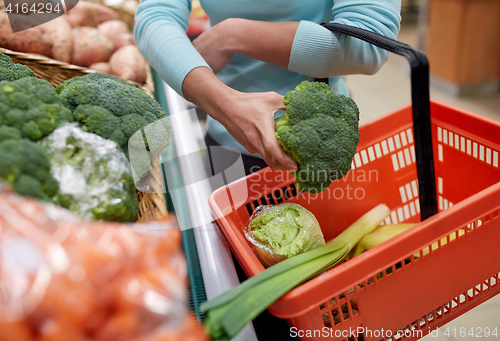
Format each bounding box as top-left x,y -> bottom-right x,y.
210,24 -> 500,341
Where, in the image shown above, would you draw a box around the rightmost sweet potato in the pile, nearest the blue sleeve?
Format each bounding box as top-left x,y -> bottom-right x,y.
109,45 -> 147,84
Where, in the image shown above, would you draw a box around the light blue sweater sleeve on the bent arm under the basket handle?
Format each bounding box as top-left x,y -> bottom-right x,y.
288,0 -> 401,78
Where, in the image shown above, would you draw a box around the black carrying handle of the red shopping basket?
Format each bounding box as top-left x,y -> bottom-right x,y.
319,23 -> 437,220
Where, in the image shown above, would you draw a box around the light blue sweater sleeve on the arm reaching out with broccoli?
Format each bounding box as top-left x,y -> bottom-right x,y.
134,0 -> 210,96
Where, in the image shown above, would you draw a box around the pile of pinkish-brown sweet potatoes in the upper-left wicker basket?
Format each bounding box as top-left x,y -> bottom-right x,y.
0,1 -> 149,84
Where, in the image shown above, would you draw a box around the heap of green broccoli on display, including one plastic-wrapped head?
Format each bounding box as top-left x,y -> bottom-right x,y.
0,54 -> 171,222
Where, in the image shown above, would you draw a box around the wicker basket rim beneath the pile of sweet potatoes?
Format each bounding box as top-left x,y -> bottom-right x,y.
0,47 -> 155,97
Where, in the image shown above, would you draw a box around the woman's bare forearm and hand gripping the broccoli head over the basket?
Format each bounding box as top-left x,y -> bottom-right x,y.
182,67 -> 297,170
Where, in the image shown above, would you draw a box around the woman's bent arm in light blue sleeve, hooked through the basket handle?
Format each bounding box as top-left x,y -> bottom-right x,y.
193,0 -> 401,78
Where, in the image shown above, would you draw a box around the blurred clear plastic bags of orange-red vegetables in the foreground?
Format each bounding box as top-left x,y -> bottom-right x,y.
0,186 -> 208,341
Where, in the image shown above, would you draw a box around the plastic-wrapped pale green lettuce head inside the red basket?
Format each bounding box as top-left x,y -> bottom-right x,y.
245,203 -> 325,267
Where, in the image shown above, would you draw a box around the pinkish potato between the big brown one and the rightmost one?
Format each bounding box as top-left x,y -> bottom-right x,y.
71,27 -> 113,66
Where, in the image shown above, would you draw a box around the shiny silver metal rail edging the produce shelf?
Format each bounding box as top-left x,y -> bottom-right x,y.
162,83 -> 257,341
